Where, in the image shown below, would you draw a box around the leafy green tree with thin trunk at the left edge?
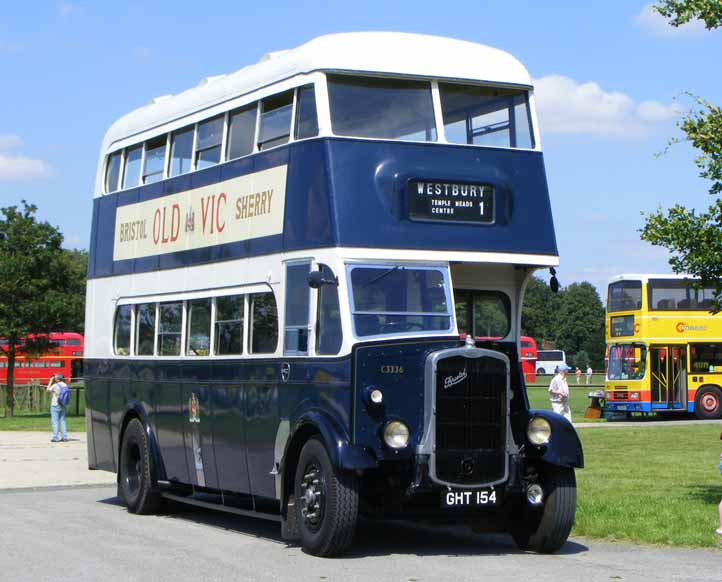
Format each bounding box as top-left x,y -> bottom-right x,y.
0,200 -> 84,416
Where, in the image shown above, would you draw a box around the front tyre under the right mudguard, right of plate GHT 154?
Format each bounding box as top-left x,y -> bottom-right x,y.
511,465 -> 577,554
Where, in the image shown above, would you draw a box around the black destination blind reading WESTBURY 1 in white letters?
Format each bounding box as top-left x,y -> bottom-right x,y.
408,180 -> 494,224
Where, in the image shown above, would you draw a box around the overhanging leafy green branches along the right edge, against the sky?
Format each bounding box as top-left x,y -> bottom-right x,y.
641,0 -> 722,312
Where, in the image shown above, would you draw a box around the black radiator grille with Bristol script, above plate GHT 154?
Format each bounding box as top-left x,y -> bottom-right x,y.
436,356 -> 507,485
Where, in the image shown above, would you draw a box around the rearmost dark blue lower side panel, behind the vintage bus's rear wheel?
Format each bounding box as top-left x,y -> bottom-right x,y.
85,360 -> 115,471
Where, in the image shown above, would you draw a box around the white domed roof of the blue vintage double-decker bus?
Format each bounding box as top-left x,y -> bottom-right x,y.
103,32 -> 531,153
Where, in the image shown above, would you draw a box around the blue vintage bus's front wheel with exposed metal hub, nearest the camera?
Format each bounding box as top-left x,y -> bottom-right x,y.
294,438 -> 358,557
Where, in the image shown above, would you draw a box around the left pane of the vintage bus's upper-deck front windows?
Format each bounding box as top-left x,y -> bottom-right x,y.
328,75 -> 436,141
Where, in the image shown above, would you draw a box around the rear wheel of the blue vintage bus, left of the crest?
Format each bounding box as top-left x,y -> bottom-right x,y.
118,418 -> 162,514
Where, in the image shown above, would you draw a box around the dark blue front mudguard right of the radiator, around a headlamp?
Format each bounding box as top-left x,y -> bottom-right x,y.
516,410 -> 584,469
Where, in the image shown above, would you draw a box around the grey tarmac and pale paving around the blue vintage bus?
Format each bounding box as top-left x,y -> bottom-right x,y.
0,423 -> 722,582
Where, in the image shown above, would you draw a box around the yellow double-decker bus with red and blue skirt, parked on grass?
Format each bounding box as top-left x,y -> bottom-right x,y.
605,275 -> 722,419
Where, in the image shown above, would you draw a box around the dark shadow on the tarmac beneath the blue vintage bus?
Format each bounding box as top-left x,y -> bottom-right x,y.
99,497 -> 589,559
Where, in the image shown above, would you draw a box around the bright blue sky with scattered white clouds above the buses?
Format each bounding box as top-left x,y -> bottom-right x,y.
0,0 -> 722,290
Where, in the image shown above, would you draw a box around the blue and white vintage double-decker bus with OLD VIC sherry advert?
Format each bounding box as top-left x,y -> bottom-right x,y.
86,33 -> 583,556
